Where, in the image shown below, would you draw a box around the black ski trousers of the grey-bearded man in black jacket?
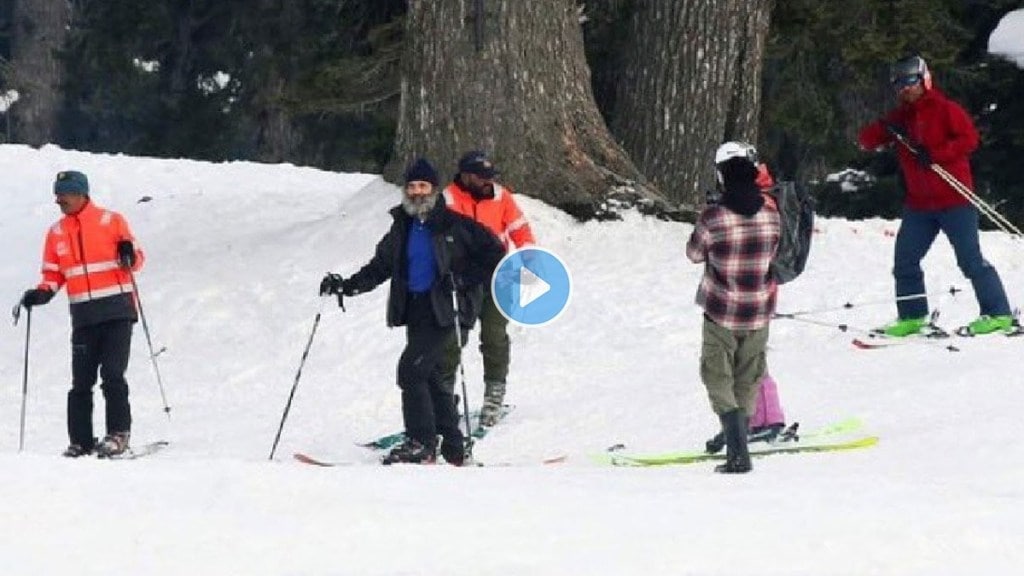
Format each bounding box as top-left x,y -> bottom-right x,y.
398,292 -> 463,447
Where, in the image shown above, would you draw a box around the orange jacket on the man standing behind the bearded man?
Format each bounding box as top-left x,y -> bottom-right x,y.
444,182 -> 536,251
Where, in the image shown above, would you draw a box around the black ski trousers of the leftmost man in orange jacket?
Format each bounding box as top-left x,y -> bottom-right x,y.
68,320 -> 132,448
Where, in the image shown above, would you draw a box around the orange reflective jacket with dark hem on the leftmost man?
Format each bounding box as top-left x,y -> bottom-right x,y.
39,201 -> 143,328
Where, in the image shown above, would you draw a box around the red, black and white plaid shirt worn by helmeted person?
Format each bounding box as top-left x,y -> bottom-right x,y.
686,204 -> 779,330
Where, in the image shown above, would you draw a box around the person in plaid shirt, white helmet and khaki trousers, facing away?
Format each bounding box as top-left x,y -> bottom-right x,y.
686,141 -> 779,474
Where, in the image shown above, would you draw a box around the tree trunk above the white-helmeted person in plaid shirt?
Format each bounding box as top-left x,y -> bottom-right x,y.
612,0 -> 772,202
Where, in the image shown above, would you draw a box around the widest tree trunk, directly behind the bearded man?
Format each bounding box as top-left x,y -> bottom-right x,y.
386,0 -> 664,218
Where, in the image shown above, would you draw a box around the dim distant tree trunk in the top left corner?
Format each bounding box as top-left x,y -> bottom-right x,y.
9,0 -> 71,146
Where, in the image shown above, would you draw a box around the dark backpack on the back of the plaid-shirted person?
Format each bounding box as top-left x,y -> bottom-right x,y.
766,182 -> 814,284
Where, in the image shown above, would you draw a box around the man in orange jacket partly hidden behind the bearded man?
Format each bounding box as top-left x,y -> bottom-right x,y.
441,151 -> 534,426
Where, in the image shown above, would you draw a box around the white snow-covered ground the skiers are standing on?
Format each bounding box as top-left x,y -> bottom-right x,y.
0,146 -> 1024,575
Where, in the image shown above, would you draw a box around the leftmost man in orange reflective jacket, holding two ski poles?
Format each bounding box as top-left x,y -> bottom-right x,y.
20,170 -> 143,458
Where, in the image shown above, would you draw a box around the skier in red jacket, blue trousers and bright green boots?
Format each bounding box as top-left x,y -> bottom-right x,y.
859,55 -> 1014,337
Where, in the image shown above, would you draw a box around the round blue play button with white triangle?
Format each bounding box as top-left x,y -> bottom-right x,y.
490,247 -> 572,326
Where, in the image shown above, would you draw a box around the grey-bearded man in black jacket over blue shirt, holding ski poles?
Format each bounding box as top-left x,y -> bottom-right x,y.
321,159 -> 505,465
